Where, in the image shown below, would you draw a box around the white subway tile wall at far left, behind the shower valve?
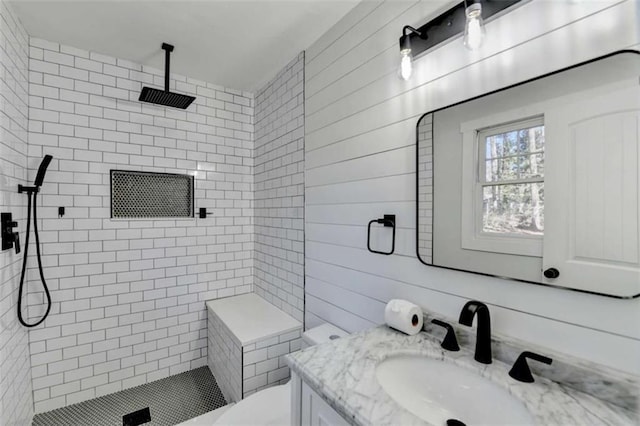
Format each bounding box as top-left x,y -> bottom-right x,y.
0,1 -> 33,425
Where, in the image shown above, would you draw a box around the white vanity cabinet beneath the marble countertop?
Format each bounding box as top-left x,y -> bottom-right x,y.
291,374 -> 349,426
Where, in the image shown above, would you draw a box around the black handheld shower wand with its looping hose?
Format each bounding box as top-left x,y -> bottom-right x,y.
18,155 -> 53,327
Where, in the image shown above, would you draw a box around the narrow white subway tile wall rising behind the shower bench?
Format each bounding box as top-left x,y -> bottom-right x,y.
255,52 -> 304,321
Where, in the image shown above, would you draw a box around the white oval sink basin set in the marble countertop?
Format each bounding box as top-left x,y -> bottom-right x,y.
376,355 -> 535,426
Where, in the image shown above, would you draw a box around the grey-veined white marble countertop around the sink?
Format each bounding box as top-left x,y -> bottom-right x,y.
287,326 -> 637,426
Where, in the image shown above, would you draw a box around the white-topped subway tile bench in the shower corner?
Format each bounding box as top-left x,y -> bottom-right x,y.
207,293 -> 302,402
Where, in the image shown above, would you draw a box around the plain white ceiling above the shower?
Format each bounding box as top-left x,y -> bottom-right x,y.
12,0 -> 358,92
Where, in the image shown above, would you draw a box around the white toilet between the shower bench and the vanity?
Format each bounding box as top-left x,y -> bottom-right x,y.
179,323 -> 348,426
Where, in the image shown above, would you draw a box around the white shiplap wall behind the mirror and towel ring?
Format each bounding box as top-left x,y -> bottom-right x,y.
305,0 -> 640,374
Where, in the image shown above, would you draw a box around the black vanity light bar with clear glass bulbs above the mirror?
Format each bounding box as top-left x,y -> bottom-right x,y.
399,0 -> 523,80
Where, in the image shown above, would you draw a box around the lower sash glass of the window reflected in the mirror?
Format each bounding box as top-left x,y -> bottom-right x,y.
482,183 -> 544,235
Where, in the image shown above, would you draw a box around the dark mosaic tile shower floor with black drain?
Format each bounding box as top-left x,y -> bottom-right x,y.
33,366 -> 227,426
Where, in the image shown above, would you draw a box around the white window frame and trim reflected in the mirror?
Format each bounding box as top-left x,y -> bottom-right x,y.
460,108 -> 544,257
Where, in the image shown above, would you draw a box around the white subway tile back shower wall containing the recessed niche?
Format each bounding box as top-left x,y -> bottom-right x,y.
29,38 -> 256,412
